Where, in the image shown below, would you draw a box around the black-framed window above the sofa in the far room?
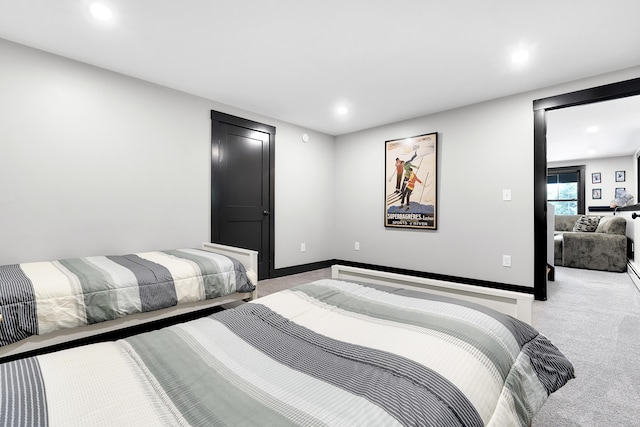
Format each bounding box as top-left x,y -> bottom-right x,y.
547,166 -> 585,215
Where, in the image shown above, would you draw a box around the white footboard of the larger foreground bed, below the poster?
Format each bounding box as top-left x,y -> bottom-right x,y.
331,265 -> 533,324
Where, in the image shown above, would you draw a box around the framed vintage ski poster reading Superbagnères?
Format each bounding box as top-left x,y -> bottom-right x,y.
384,132 -> 438,230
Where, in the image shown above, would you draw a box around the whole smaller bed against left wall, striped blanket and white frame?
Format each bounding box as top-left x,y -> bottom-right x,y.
0,243 -> 258,360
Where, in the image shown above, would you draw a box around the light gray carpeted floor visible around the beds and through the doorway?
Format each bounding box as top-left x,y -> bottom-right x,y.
251,267 -> 640,427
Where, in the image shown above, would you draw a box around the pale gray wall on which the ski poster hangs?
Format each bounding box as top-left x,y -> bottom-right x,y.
335,67 -> 640,287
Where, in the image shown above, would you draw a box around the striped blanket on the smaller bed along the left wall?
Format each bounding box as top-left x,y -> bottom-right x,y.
0,249 -> 255,346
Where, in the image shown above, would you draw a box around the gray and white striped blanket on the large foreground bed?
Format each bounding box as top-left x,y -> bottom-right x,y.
0,280 -> 573,427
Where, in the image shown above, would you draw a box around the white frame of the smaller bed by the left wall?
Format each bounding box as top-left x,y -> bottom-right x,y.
0,243 -> 258,362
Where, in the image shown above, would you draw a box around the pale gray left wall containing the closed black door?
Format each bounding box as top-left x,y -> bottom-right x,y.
0,40 -> 334,268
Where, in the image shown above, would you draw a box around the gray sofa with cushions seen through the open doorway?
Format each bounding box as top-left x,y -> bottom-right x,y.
553,215 -> 627,272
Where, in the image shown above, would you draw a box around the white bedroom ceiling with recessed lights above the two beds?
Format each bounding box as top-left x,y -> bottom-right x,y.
0,0 -> 640,135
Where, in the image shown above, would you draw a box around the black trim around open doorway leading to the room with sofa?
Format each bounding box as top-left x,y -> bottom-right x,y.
533,78 -> 640,301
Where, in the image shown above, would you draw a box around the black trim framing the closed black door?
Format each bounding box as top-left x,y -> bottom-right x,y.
211,110 -> 276,278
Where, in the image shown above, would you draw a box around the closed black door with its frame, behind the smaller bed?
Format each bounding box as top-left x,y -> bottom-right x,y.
211,111 -> 276,280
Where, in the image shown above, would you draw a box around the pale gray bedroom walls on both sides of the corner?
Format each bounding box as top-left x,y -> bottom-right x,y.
0,36 -> 640,287
